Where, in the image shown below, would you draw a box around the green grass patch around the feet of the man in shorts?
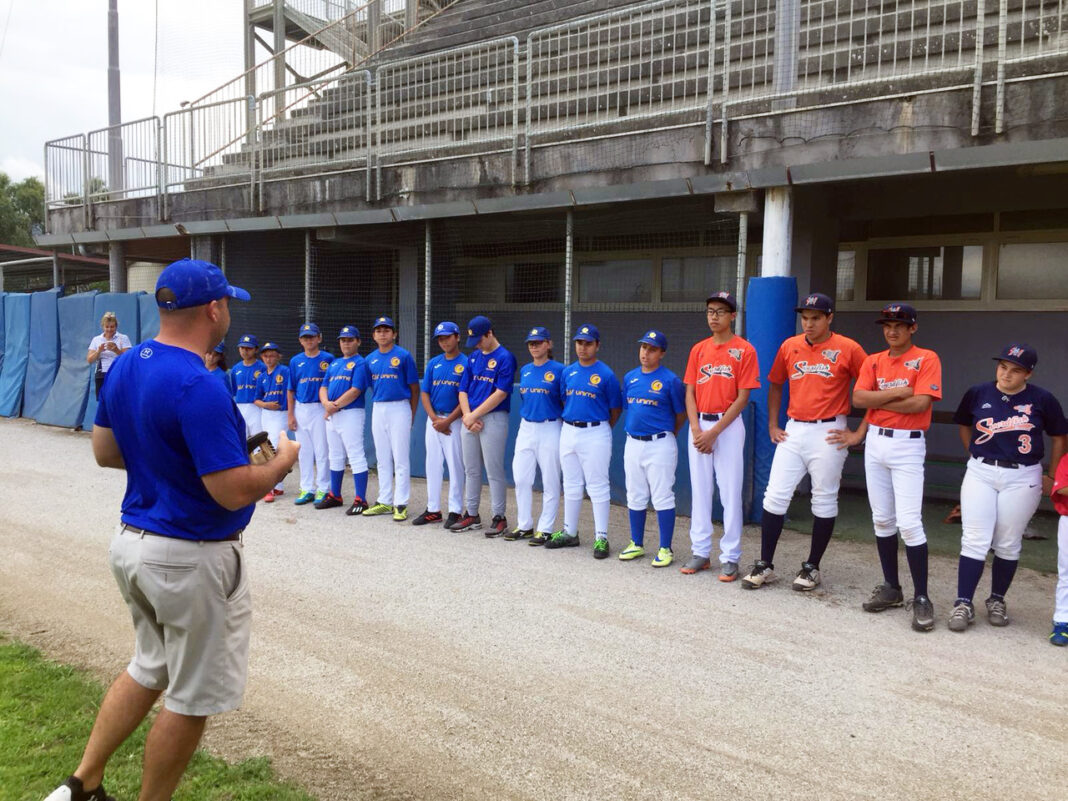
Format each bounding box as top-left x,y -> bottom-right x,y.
0,634 -> 314,801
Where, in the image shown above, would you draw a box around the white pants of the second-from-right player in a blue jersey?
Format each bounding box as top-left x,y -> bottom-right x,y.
560,422 -> 612,535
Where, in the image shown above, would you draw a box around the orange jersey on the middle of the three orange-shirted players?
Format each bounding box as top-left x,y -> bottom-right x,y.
768,333 -> 867,420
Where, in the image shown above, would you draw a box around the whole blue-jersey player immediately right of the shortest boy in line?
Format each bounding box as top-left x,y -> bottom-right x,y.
287,323 -> 333,506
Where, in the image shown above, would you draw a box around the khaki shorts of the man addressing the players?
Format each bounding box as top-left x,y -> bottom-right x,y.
108,524 -> 252,716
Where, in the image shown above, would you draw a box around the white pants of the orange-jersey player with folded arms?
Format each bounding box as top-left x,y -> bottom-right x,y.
864,426 -> 927,545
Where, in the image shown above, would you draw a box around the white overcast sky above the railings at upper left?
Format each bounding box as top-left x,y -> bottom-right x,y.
0,0 -> 245,180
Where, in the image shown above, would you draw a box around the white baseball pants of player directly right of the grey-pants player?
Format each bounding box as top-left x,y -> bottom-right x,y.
512,420 -> 571,533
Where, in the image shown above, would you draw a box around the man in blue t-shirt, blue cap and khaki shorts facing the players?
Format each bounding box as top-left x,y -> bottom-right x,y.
43,258 -> 297,801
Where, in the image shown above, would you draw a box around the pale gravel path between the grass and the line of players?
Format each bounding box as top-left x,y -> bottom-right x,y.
0,420 -> 1068,801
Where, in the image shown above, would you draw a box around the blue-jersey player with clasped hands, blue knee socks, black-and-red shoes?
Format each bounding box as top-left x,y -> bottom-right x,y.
315,326 -> 371,515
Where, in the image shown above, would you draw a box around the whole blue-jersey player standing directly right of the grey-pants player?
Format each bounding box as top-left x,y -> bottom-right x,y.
504,326 -> 564,545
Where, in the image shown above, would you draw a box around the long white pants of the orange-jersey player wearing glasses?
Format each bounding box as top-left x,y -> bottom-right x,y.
688,417 -> 745,564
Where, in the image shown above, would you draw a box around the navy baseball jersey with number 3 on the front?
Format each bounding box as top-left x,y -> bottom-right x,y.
953,381 -> 1068,465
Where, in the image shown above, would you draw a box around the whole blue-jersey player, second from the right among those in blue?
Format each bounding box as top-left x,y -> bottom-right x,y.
545,324 -> 623,559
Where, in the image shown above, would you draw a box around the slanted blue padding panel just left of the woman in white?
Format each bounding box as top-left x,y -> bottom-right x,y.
37,290 -> 99,428
